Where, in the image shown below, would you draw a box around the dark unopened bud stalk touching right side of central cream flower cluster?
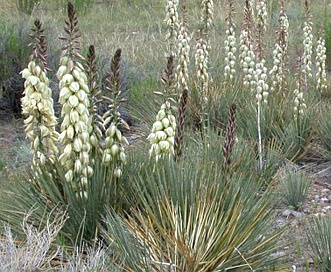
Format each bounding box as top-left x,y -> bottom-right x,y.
174,89 -> 188,161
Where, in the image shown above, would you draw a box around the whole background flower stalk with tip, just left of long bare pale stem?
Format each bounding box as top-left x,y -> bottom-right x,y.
239,0 -> 256,88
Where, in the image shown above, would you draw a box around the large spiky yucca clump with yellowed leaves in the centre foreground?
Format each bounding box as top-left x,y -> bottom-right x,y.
103,131 -> 286,271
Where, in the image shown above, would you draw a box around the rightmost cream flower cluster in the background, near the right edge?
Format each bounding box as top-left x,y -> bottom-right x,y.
316,37 -> 328,92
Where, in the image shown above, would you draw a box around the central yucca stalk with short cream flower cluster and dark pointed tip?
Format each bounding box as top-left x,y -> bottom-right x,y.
147,56 -> 177,161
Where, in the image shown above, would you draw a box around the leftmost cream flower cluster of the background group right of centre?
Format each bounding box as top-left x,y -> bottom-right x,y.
224,24 -> 237,80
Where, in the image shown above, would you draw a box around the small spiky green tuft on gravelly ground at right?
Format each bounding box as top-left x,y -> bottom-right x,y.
281,169 -> 312,210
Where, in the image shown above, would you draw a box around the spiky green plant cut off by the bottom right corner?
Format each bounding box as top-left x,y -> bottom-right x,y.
307,217 -> 331,272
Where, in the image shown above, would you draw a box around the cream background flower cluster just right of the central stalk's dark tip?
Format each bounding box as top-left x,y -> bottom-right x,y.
176,22 -> 191,90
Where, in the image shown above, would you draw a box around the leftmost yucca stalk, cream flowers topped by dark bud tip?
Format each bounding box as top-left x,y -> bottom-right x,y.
21,20 -> 58,167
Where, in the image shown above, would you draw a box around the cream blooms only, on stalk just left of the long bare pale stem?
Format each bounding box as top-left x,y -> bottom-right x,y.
239,29 -> 256,88
